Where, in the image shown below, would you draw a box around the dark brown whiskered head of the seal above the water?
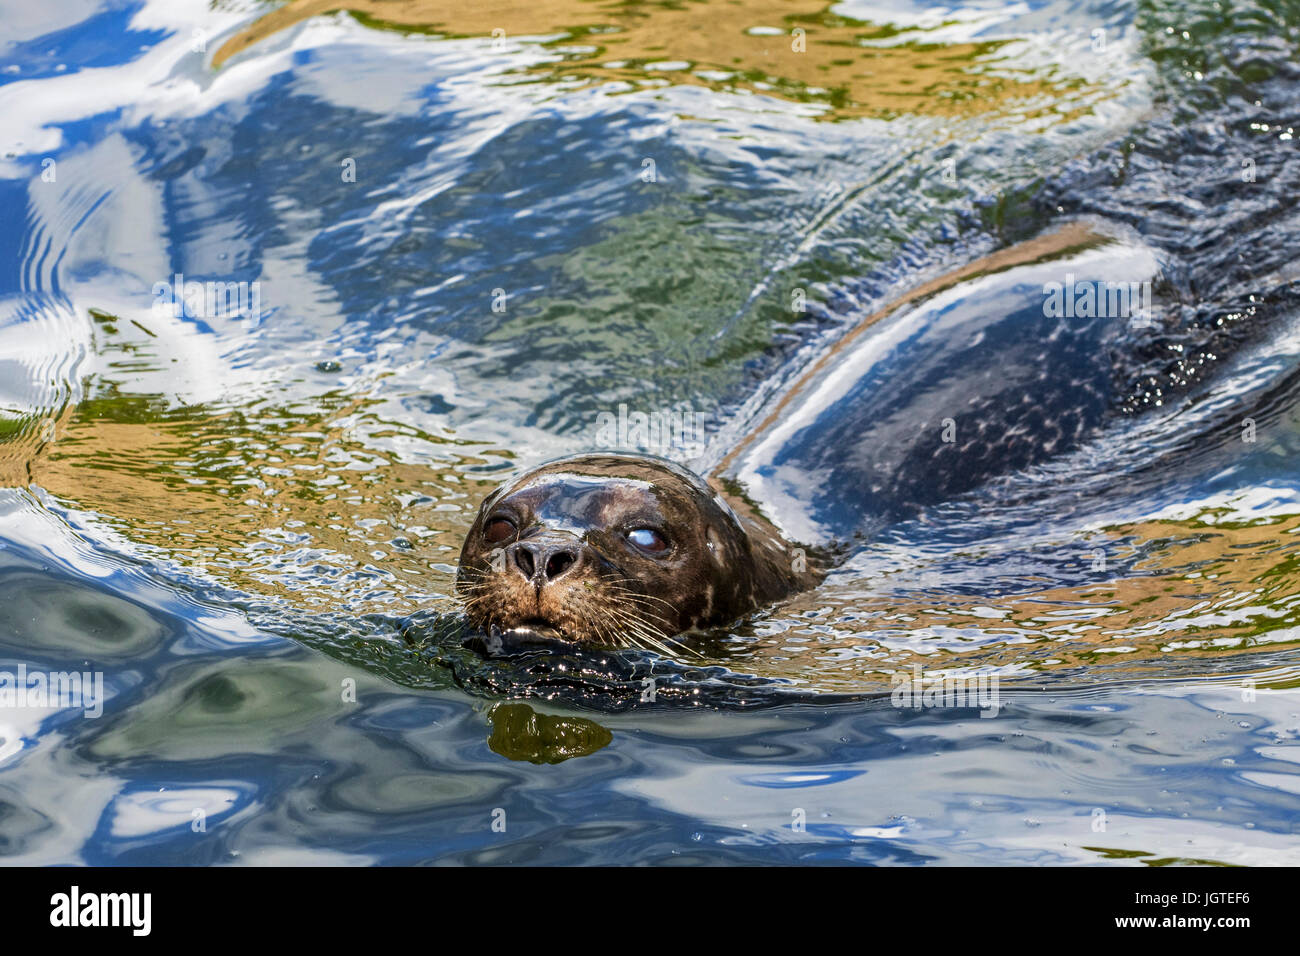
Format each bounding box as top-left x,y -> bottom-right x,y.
456,454 -> 818,649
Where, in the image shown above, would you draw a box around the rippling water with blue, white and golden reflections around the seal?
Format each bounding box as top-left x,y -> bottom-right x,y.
0,0 -> 1300,865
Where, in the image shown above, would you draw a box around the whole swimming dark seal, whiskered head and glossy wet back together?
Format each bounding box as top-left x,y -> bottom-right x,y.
456,226 -> 1158,649
